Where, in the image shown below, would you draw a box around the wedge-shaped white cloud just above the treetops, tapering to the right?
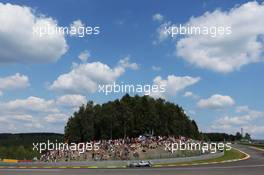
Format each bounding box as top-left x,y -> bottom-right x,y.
151,75 -> 201,98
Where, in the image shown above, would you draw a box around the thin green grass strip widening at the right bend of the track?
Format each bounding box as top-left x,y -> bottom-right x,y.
155,149 -> 246,166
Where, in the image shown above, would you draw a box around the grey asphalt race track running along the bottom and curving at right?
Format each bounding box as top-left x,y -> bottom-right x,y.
0,145 -> 264,175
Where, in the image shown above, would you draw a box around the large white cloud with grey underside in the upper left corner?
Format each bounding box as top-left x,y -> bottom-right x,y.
0,3 -> 68,63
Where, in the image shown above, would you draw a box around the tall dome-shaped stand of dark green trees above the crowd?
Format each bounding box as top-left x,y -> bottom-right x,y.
65,94 -> 200,142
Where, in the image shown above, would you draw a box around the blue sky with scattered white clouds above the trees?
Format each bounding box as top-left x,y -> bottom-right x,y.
0,0 -> 264,139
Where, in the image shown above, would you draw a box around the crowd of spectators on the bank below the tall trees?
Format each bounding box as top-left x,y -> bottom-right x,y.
40,135 -> 200,162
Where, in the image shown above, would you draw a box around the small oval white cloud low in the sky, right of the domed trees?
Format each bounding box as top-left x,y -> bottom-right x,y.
197,94 -> 235,109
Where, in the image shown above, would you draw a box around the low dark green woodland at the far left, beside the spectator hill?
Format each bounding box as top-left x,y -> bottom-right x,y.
0,133 -> 63,160
